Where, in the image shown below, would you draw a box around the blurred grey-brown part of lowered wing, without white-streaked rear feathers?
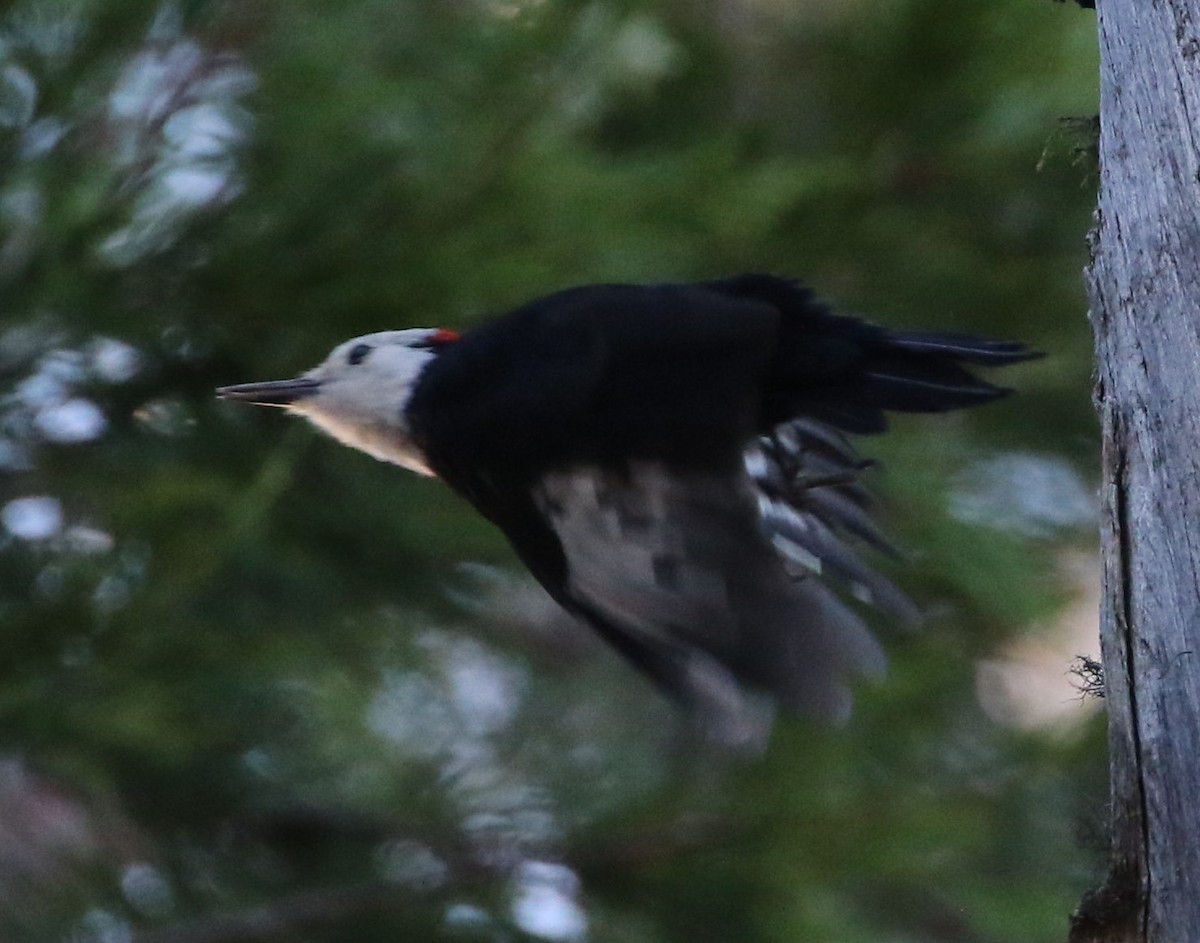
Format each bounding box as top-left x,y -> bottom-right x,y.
536,455 -> 897,717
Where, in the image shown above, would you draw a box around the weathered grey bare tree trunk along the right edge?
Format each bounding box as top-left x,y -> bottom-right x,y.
1072,0 -> 1200,943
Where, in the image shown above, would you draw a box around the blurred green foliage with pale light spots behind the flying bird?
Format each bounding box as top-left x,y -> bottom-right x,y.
0,0 -> 1105,943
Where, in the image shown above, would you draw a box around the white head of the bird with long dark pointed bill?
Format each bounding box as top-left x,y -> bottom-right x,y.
217,328 -> 457,475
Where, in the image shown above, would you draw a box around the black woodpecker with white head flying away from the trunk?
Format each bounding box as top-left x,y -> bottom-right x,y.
217,275 -> 1036,719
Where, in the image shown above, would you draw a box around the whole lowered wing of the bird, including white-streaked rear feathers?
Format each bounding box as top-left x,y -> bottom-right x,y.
427,421 -> 916,726
